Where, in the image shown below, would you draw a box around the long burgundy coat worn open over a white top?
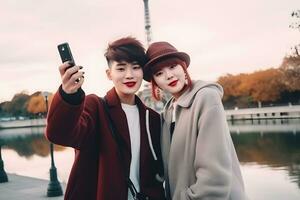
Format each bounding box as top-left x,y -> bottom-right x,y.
46,88 -> 165,200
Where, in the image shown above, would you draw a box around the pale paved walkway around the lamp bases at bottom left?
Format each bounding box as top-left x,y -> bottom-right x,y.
0,174 -> 65,200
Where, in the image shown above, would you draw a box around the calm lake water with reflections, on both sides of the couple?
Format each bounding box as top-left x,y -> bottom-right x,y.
0,119 -> 300,200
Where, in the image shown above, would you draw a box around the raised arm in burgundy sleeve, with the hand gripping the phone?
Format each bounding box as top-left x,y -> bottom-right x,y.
46,63 -> 98,149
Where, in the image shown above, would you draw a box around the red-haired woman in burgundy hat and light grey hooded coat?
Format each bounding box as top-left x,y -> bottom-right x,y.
144,42 -> 247,200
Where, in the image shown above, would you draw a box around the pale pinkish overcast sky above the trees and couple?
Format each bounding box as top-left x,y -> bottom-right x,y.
0,0 -> 300,102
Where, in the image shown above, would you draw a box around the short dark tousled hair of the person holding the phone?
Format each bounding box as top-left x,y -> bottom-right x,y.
104,37 -> 147,67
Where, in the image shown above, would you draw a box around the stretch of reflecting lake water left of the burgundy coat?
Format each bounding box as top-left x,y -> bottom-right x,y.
0,127 -> 74,182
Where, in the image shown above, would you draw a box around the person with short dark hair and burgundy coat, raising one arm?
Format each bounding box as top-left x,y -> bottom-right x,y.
46,37 -> 165,200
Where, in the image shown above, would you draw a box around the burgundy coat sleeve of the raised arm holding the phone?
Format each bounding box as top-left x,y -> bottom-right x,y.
45,92 -> 98,149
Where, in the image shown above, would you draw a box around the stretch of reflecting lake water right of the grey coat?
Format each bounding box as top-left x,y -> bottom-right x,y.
229,119 -> 300,199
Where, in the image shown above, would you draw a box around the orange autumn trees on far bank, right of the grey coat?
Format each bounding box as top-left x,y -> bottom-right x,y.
218,56 -> 300,107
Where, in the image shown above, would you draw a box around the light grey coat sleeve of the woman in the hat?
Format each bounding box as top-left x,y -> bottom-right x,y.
181,91 -> 232,200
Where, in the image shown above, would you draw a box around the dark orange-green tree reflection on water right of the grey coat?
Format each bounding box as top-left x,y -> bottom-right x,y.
232,132 -> 300,188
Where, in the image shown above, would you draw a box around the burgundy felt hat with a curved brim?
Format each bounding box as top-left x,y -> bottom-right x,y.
144,42 -> 190,82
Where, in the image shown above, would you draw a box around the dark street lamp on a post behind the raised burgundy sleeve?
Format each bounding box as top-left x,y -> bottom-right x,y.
42,92 -> 63,197
